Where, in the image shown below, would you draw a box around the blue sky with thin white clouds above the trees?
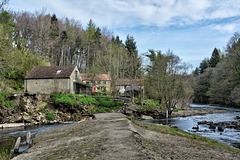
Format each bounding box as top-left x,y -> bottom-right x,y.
8,0 -> 240,68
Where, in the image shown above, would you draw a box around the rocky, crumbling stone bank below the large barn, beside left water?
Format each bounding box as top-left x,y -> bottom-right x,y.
0,93 -> 92,128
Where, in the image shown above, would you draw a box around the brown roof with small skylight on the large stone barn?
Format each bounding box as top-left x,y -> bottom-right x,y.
25,66 -> 76,79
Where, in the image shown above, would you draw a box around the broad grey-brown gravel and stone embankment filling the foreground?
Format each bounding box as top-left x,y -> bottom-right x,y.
13,113 -> 240,160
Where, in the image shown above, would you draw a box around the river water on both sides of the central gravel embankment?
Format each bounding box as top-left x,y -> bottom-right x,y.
0,104 -> 240,155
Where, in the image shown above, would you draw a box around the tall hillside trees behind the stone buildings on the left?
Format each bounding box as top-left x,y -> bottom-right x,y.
0,0 -> 142,90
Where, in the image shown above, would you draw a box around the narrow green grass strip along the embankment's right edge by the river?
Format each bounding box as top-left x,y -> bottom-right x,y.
127,117 -> 240,153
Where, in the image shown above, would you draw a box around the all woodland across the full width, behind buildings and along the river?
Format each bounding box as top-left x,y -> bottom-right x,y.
0,0 -> 240,109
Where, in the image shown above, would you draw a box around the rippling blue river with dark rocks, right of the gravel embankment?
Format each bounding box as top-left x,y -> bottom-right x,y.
144,104 -> 240,149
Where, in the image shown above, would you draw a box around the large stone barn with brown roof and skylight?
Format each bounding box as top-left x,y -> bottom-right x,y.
24,66 -> 88,94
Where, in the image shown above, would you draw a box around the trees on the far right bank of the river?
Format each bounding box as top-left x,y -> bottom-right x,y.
193,33 -> 240,106
